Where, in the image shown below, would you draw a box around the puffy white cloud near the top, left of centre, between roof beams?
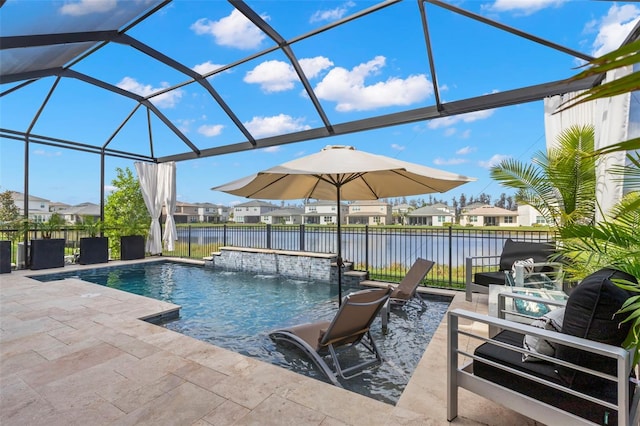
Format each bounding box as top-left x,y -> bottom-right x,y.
191,9 -> 269,49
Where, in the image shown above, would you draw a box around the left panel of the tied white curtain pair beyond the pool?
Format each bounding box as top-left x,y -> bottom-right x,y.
135,162 -> 164,255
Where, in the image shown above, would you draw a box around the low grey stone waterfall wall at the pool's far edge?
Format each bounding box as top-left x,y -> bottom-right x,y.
204,247 -> 368,285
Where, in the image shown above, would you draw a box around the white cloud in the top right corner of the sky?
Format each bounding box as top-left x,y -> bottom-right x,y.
587,4 -> 640,57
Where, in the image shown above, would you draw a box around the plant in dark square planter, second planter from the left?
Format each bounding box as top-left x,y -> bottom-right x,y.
29,213 -> 65,270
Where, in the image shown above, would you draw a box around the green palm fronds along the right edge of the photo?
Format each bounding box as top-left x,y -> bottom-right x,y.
548,40 -> 640,365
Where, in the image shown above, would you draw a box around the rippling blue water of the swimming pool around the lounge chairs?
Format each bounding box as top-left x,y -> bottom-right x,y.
32,262 -> 450,404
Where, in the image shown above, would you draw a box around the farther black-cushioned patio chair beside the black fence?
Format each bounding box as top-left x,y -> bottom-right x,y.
465,238 -> 563,302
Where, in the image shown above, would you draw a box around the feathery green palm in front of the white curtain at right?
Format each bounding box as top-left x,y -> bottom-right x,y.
491,125 -> 596,229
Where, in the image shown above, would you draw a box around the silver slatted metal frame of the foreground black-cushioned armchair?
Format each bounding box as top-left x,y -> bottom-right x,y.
447,293 -> 640,426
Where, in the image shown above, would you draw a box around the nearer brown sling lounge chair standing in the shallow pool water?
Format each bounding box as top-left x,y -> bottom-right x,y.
269,287 -> 392,387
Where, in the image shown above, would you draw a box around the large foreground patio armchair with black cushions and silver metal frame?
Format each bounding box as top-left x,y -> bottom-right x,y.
447,269 -> 640,426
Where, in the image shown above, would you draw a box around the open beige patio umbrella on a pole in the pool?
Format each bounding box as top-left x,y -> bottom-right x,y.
211,145 -> 475,303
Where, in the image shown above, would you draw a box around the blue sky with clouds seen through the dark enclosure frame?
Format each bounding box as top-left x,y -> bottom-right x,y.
0,0 -> 640,205
